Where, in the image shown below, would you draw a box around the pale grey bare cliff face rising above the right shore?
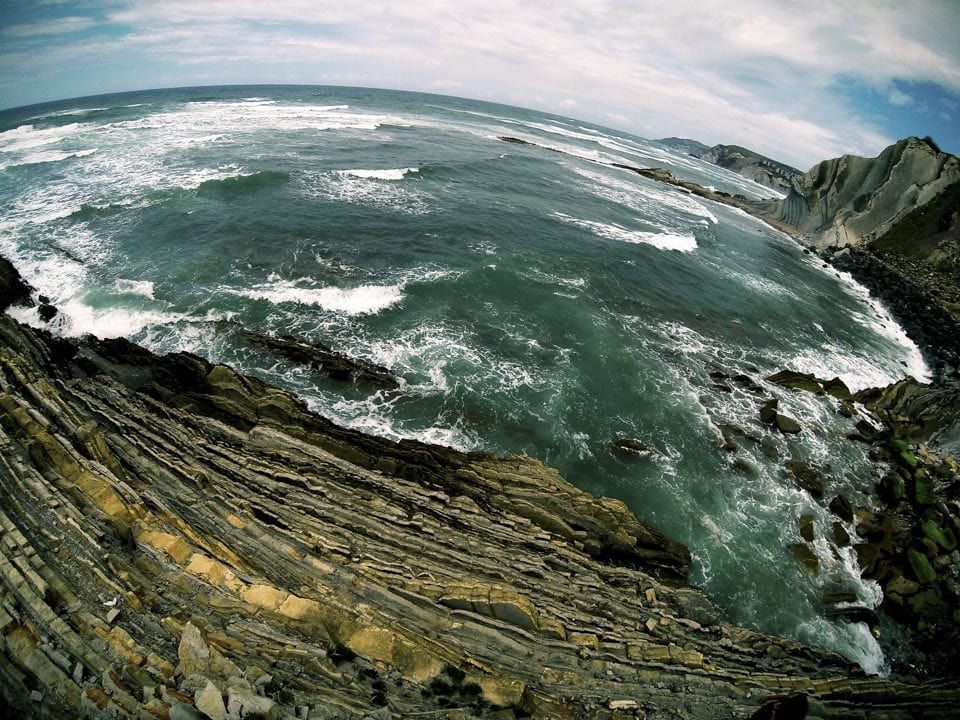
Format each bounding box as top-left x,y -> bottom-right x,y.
770,137 -> 960,249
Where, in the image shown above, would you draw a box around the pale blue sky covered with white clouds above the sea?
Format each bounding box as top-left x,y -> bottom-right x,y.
0,0 -> 960,170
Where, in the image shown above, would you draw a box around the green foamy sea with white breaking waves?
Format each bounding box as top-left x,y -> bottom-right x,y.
0,87 -> 926,672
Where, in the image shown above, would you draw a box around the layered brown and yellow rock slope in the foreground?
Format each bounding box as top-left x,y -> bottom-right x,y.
0,266 -> 960,720
